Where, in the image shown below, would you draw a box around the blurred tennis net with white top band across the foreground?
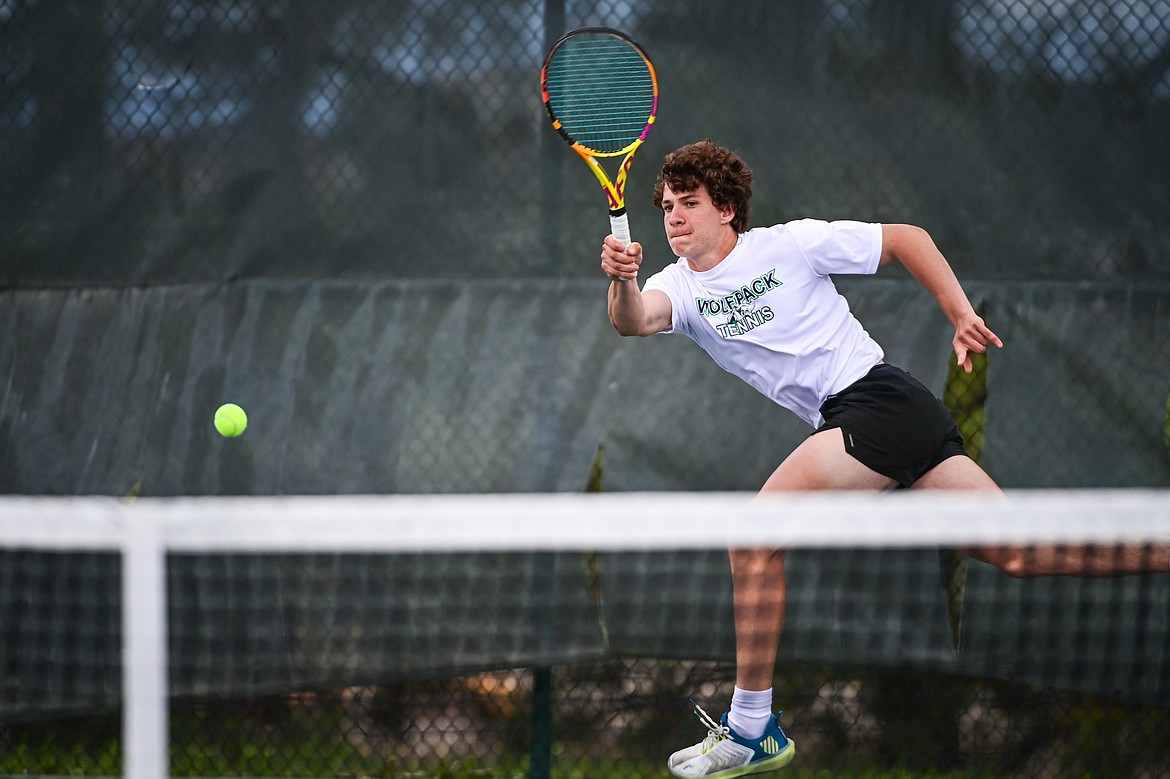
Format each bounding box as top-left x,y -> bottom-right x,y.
0,490 -> 1170,779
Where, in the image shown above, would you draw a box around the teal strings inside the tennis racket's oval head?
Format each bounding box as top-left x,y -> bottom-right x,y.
545,40 -> 656,154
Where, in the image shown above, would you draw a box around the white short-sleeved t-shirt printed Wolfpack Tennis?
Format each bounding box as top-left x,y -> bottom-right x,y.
644,219 -> 882,427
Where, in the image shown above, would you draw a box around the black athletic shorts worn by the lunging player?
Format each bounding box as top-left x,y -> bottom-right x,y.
813,363 -> 966,487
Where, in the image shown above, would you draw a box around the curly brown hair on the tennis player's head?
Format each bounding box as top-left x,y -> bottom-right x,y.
654,140 -> 751,233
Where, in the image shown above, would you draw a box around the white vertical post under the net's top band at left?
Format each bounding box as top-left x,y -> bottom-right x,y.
122,512 -> 170,779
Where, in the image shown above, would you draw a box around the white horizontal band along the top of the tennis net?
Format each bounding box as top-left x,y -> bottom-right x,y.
0,489 -> 1170,552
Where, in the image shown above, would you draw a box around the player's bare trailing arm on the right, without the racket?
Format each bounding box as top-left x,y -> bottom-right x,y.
881,225 -> 1004,373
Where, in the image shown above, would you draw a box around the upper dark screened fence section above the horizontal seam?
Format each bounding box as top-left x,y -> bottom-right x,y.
0,0 -> 1170,284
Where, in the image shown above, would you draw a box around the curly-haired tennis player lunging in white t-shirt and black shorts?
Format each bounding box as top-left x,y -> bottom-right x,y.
601,140 -> 1170,779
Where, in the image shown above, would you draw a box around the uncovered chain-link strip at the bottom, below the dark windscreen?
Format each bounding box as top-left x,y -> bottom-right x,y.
0,660 -> 1170,779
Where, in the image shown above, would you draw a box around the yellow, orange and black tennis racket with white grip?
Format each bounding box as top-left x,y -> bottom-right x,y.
541,27 -> 658,251
